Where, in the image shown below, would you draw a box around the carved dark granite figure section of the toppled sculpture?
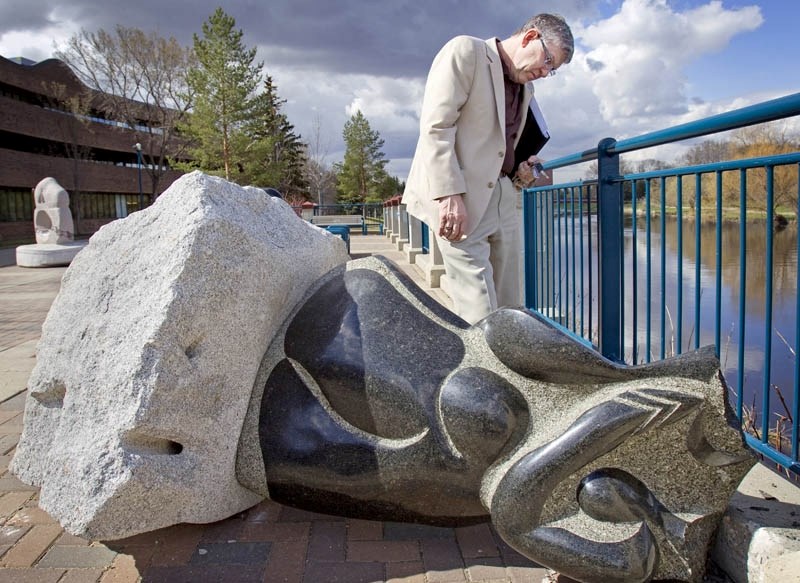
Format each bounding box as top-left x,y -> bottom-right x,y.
237,258 -> 755,583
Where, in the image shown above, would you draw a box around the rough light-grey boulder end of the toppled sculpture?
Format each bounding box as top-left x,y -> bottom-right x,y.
12,173 -> 347,539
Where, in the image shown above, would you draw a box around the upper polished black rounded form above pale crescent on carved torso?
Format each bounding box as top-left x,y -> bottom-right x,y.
285,270 -> 464,438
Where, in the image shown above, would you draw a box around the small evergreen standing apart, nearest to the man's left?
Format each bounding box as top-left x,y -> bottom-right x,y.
336,111 -> 388,203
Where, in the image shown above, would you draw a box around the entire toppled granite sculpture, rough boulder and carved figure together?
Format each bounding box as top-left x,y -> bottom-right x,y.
12,174 -> 754,582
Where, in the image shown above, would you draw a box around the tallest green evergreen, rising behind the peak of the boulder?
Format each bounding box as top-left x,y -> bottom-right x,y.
183,8 -> 264,180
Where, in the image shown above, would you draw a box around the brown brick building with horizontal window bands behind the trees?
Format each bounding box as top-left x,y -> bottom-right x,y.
0,56 -> 181,245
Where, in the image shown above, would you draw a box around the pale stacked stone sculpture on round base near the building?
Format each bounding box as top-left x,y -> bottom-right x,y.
16,177 -> 86,267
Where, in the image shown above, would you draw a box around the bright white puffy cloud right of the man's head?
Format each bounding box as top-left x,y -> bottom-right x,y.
576,0 -> 763,134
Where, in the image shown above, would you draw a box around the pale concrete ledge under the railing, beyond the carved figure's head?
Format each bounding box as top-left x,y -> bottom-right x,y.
712,464 -> 800,583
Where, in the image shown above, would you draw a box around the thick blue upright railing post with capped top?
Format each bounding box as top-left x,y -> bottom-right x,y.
597,138 -> 625,362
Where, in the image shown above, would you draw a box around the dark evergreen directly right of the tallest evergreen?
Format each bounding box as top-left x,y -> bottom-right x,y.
241,75 -> 308,199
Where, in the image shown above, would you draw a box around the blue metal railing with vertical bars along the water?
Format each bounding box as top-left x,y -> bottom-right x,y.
523,93 -> 800,474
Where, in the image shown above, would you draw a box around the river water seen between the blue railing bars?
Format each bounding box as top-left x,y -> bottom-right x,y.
537,214 -> 798,450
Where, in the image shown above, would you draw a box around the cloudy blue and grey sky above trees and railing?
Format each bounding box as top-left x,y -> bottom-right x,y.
0,0 -> 800,180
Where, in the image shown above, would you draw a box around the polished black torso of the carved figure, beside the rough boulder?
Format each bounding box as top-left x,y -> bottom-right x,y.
260,270 -> 494,525
